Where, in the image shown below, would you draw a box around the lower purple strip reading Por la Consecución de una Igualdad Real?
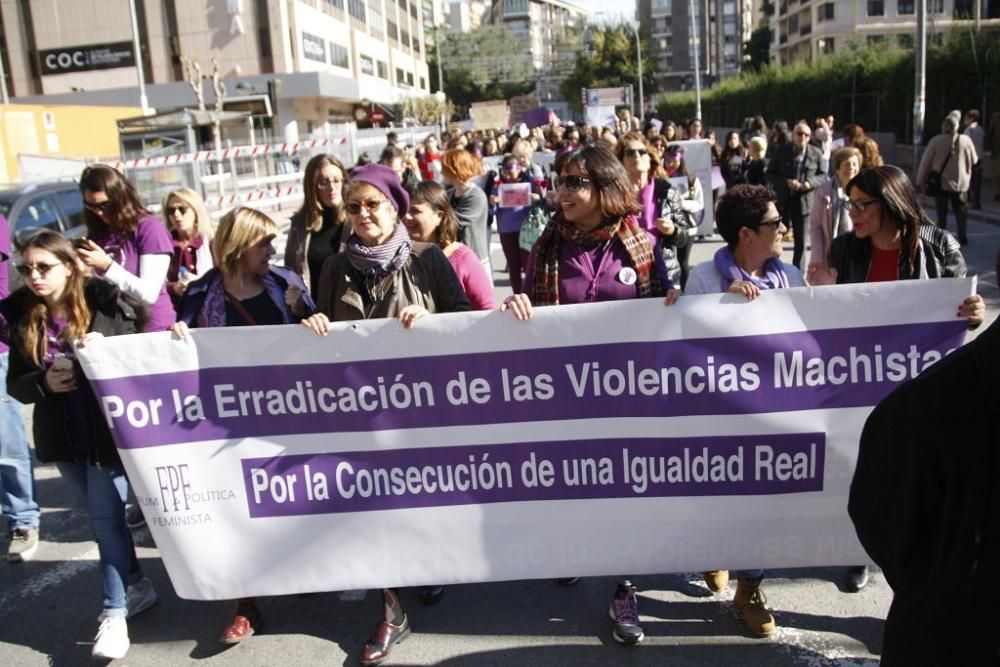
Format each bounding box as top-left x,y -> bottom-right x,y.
242,433 -> 826,518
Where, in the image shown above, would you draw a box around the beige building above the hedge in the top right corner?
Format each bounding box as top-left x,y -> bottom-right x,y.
771,0 -> 1000,64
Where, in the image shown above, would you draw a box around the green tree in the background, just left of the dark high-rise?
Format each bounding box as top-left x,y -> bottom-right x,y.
560,23 -> 656,111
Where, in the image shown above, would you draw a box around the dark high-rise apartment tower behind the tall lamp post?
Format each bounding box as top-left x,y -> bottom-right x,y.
636,0 -> 754,91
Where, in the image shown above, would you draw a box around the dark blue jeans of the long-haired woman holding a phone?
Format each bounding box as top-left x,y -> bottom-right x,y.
56,463 -> 142,616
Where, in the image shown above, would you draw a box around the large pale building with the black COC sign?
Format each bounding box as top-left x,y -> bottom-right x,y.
0,0 -> 438,139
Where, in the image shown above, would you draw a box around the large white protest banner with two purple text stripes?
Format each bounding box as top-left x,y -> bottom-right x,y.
80,279 -> 972,599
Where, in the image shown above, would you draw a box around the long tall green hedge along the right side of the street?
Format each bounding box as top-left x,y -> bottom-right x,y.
657,30 -> 1000,142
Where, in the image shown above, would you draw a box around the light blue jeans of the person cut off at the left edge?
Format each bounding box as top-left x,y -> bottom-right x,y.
0,354 -> 39,530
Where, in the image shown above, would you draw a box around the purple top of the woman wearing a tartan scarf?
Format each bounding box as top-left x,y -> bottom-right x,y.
524,232 -> 667,304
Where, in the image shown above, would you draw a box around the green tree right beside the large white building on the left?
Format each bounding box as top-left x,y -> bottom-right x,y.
428,26 -> 535,115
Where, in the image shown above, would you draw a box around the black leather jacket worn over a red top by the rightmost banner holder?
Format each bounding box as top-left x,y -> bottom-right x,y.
829,225 -> 965,285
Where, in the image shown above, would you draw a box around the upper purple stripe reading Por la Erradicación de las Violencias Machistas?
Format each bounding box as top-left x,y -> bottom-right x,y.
92,319 -> 965,449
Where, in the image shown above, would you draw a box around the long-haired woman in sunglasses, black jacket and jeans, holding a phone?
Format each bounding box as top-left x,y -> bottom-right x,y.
0,231 -> 154,660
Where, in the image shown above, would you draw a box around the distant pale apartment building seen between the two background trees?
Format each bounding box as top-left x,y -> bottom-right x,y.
482,0 -> 588,102
